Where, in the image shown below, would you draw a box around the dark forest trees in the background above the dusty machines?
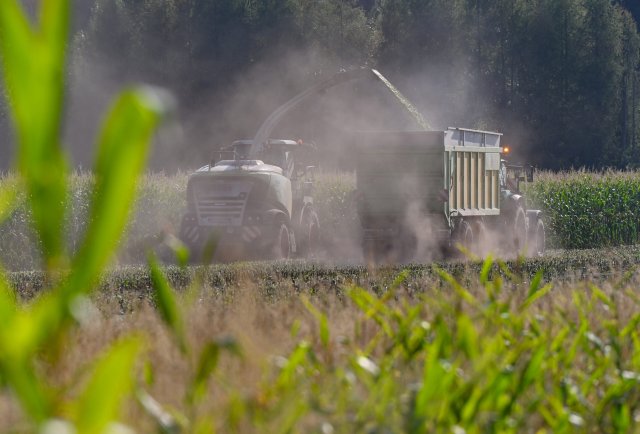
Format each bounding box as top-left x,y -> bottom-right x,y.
3,0 -> 640,169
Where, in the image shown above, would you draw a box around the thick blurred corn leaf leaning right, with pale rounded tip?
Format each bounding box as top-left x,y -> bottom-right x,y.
66,89 -> 163,293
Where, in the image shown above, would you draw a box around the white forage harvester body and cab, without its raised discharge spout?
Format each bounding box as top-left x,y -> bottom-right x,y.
180,139 -> 319,261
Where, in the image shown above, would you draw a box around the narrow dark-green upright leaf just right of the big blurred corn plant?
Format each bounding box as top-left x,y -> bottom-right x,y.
149,256 -> 182,353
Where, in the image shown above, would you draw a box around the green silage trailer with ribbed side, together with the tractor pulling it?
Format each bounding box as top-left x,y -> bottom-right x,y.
356,128 -> 545,262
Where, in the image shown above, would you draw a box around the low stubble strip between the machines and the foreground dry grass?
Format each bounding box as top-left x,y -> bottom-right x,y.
9,246 -> 640,309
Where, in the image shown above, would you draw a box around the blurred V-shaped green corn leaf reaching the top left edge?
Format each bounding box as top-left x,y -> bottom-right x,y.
0,0 -> 69,269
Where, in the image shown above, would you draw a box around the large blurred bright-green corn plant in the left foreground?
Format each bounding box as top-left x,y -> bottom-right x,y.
0,0 -> 164,433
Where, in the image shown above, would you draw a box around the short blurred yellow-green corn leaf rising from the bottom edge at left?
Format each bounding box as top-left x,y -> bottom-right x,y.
77,338 -> 141,434
